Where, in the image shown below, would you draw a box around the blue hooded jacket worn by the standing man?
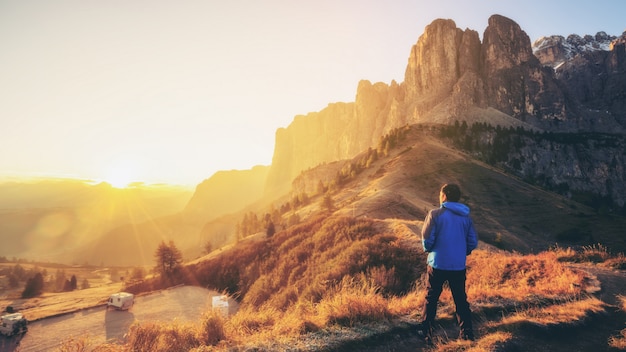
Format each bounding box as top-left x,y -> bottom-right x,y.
422,202 -> 478,270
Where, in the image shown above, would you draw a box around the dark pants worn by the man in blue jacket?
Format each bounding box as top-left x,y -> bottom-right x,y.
422,266 -> 474,337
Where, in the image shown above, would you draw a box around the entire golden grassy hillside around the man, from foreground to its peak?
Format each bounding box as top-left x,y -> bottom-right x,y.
50,126 -> 626,351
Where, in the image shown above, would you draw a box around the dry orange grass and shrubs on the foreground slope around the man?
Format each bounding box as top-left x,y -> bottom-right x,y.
61,217 -> 604,351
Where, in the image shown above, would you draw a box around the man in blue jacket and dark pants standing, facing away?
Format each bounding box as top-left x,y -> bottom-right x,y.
418,184 -> 478,343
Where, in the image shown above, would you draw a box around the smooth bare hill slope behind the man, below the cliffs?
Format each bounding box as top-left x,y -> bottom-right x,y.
301,126 -> 626,253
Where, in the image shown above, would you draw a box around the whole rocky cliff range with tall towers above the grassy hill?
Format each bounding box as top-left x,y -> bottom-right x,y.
266,15 -> 626,204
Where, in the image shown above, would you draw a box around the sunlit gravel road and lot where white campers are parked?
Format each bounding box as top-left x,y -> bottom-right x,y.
0,286 -> 237,352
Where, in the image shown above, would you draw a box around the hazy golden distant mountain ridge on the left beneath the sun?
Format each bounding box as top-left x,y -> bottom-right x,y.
0,179 -> 192,264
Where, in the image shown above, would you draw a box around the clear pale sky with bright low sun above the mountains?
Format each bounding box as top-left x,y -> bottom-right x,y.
0,0 -> 626,186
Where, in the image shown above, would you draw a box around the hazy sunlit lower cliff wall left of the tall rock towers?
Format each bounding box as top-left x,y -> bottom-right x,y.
267,80 -> 408,194
